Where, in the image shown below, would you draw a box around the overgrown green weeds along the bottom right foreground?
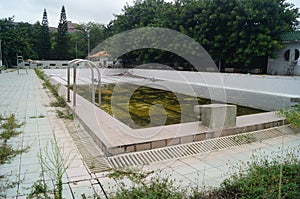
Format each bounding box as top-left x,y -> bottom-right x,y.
108,145 -> 300,199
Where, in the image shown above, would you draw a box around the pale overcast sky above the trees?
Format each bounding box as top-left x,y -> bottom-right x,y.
0,0 -> 300,27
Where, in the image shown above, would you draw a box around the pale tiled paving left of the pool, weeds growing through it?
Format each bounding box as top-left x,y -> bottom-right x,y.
0,70 -> 95,198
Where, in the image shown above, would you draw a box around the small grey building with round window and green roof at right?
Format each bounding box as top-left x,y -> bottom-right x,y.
267,42 -> 300,75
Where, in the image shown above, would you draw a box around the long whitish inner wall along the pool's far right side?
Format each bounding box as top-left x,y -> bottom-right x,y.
128,69 -> 300,111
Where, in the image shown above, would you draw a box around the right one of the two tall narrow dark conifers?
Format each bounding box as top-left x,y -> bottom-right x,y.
54,6 -> 69,60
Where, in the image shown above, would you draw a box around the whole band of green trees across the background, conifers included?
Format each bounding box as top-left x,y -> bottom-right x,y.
0,0 -> 300,69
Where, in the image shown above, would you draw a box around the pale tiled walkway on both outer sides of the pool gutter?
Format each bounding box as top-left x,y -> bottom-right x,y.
0,70 -> 300,198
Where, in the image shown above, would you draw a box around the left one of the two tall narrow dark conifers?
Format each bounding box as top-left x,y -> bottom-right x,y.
38,9 -> 51,60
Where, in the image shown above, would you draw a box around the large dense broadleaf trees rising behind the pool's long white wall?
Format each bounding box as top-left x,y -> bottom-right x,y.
108,0 -> 299,70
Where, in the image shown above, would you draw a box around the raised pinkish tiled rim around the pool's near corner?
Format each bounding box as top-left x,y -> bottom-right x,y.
46,70 -> 284,156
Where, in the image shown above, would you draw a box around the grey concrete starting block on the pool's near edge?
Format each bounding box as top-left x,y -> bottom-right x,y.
200,104 -> 237,129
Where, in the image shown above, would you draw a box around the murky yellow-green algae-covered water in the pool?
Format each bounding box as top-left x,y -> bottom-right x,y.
77,83 -> 264,129
